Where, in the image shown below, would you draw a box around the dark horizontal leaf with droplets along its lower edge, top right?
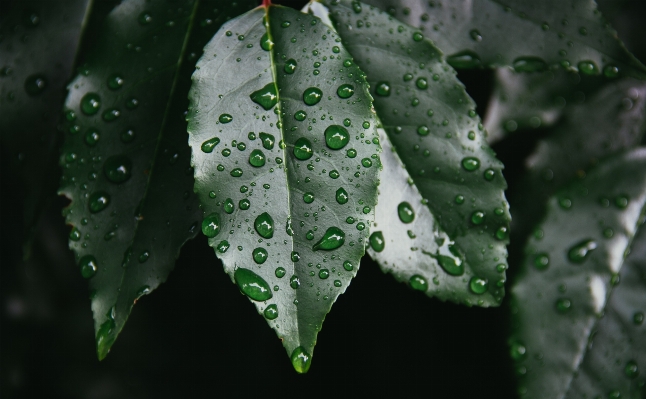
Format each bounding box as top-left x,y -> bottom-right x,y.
366,0 -> 646,79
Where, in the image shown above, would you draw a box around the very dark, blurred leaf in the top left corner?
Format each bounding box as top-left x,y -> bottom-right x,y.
0,0 -> 88,257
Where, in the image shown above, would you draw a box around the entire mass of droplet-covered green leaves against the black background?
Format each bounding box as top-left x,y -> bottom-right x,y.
0,0 -> 646,398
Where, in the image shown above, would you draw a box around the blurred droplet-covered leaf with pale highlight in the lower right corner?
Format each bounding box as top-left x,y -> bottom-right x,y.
510,148 -> 646,399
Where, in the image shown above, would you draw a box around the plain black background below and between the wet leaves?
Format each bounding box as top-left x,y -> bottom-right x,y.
0,0 -> 646,399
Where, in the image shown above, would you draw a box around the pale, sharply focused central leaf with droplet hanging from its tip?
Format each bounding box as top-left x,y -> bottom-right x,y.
189,6 -> 380,373
